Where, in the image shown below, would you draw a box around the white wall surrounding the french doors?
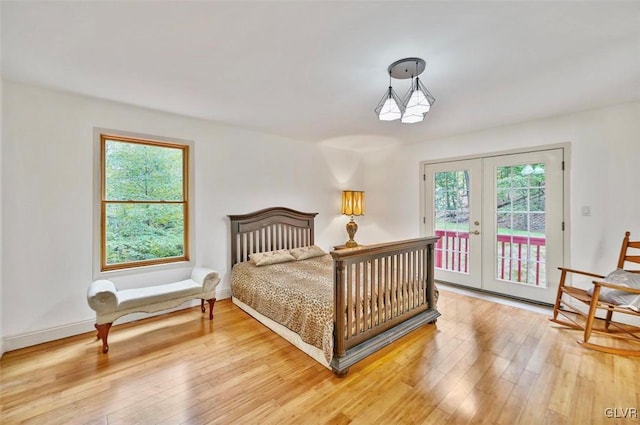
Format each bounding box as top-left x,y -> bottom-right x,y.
362,102 -> 640,288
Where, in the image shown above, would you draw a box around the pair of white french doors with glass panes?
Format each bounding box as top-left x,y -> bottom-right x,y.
424,149 -> 564,303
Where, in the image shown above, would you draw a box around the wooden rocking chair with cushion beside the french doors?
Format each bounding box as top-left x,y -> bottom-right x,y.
549,232 -> 640,356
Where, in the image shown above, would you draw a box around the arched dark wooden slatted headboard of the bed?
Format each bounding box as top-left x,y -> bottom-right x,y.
227,207 -> 318,267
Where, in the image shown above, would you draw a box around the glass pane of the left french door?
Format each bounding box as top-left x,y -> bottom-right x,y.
433,170 -> 470,273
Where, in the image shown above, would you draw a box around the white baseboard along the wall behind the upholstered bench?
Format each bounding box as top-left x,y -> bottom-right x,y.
0,288 -> 231,356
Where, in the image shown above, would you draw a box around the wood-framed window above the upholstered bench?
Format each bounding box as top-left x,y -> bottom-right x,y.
100,134 -> 189,271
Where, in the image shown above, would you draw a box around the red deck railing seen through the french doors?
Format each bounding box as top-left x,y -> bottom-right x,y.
435,230 -> 546,286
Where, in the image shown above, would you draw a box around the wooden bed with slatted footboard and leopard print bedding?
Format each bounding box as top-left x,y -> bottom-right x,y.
228,207 -> 440,376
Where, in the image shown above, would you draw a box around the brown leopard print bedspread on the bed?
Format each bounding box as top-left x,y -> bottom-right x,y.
231,255 -> 333,363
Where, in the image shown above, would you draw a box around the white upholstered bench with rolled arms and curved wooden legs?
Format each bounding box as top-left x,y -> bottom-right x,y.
87,267 -> 220,353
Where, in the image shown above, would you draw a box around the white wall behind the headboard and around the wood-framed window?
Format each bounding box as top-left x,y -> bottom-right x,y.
0,81 -> 358,350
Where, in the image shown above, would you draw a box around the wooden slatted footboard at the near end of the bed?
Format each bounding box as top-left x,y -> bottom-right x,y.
331,237 -> 440,376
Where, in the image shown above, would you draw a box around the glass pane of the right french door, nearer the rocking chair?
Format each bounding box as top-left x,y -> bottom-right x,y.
495,163 -> 547,287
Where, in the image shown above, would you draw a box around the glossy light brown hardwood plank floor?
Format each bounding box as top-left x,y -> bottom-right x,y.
0,291 -> 640,425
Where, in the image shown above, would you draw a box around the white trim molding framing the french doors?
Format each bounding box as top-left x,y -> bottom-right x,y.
418,142 -> 571,290
